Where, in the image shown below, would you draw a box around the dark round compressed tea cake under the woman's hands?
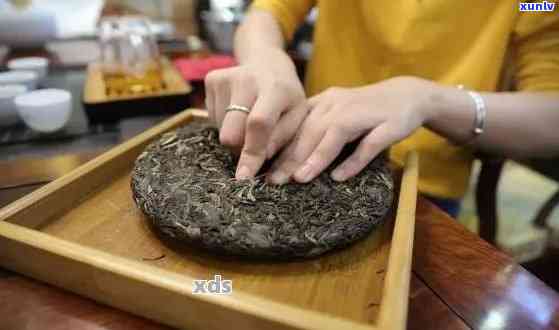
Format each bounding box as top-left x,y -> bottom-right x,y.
131,123 -> 394,259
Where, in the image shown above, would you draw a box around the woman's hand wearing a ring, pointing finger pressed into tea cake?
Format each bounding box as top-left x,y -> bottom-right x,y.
205,49 -> 308,179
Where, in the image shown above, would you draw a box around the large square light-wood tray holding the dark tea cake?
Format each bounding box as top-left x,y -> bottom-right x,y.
0,110 -> 418,330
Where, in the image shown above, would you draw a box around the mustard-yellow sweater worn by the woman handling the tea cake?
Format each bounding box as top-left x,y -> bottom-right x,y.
252,0 -> 559,198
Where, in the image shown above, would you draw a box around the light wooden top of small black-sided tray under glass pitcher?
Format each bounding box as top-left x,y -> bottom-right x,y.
83,57 -> 192,104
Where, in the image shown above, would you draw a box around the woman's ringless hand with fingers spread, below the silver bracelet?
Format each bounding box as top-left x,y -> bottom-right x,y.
269,77 -> 437,184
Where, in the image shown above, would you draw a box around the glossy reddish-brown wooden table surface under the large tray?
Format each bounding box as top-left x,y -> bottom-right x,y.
0,153 -> 559,330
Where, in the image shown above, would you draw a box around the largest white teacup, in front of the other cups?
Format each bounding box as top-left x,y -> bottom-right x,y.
14,89 -> 72,133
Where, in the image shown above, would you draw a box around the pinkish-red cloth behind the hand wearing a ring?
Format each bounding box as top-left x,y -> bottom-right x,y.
174,55 -> 237,81
